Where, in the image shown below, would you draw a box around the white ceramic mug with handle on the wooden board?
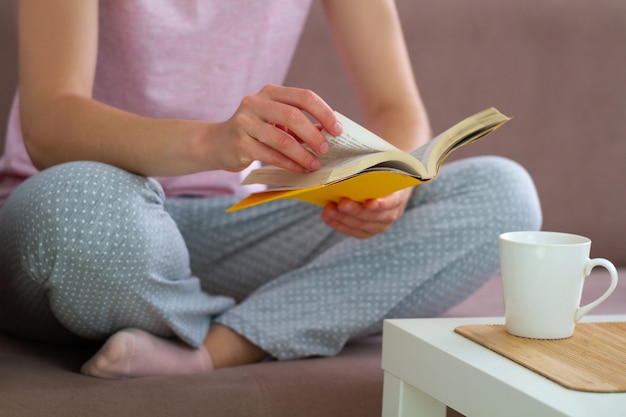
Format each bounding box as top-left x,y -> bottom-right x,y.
499,231 -> 617,339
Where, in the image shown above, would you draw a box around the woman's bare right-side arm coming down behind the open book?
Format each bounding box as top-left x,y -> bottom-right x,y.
324,0 -> 431,151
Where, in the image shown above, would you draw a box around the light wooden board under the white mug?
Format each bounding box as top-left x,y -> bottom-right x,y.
454,322 -> 626,392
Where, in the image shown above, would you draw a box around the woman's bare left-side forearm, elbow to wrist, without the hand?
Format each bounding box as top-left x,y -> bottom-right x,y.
21,95 -> 220,176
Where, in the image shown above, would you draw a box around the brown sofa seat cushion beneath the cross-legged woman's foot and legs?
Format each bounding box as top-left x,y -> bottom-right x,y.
0,334 -> 383,417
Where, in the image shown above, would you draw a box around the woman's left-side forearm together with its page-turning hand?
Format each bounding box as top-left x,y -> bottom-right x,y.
21,85 -> 341,176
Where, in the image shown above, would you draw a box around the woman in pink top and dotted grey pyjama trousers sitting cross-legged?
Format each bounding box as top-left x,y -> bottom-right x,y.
0,0 -> 540,378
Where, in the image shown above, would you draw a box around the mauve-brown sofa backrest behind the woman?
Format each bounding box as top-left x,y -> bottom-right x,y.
287,0 -> 626,265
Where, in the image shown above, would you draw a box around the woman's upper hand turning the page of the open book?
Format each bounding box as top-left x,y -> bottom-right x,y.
213,85 -> 342,173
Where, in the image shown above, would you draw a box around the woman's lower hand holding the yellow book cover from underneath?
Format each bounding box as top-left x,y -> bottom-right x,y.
322,188 -> 413,239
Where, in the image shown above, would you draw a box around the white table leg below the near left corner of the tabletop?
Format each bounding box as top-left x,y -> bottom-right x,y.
383,372 -> 446,417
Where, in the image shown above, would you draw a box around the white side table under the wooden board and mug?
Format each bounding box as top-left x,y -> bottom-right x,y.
382,315 -> 626,417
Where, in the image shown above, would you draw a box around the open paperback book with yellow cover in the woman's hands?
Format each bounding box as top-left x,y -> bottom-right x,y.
227,107 -> 510,212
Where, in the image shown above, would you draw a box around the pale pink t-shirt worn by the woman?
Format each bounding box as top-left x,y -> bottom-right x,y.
0,0 -> 312,206
